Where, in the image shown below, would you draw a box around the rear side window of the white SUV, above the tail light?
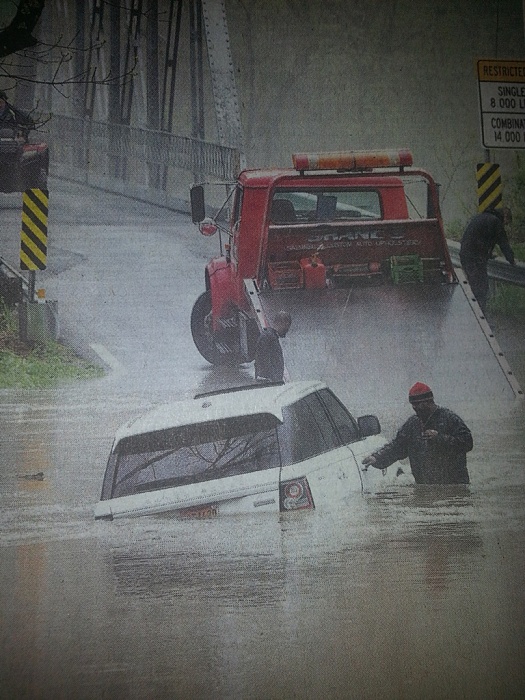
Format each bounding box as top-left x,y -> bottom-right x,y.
279,394 -> 341,464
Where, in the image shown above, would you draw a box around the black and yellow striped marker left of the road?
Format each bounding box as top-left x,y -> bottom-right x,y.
20,189 -> 49,270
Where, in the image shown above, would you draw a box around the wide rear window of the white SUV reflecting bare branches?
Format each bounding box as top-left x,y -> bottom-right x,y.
102,414 -> 280,499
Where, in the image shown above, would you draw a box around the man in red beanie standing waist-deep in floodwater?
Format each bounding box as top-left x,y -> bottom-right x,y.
362,382 -> 473,484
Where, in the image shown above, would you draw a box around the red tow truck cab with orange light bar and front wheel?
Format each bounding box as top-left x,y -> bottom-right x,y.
191,150 -> 456,364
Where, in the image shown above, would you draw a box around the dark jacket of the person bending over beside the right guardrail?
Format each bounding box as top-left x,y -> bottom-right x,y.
460,212 -> 514,265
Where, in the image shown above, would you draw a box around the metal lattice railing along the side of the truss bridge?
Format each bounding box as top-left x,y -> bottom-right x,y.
47,114 -> 240,211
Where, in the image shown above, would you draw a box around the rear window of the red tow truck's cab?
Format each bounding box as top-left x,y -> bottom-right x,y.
270,188 -> 381,225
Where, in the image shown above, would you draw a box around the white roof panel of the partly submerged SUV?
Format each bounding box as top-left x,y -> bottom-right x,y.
115,381 -> 326,444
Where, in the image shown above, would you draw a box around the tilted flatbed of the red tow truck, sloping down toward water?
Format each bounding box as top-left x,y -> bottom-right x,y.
255,283 -> 522,406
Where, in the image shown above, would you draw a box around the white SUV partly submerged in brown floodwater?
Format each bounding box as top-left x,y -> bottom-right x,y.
95,381 -> 406,520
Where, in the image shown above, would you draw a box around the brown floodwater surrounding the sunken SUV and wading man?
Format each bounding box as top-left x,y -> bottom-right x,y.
0,382 -> 525,700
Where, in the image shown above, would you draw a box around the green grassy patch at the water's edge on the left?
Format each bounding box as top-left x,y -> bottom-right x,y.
0,299 -> 104,389
